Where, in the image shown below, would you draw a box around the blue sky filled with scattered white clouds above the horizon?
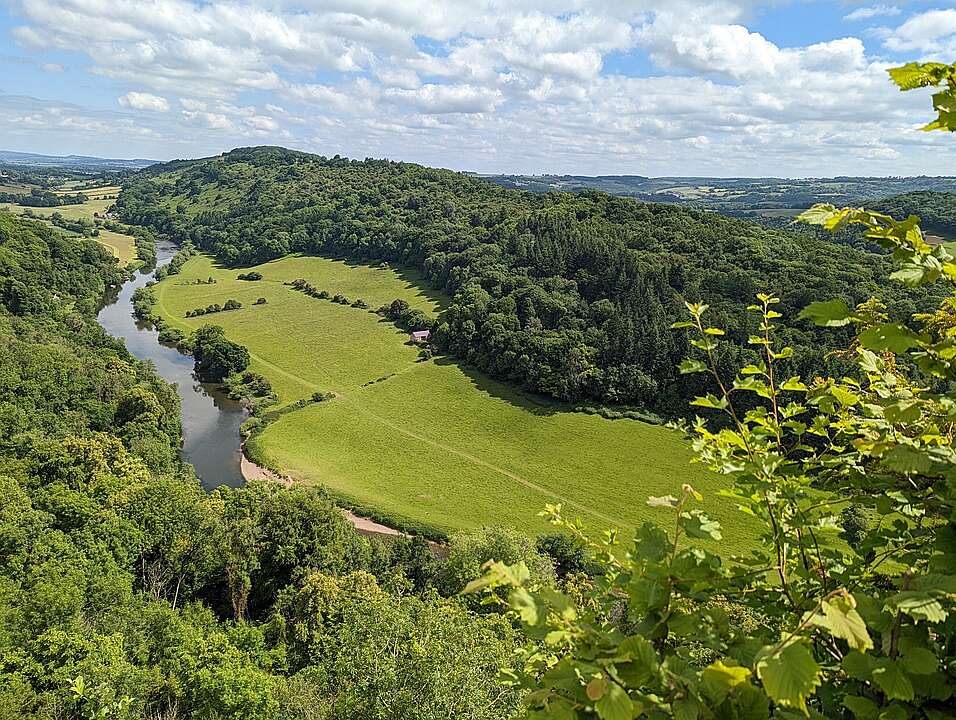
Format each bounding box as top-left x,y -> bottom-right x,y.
0,0 -> 956,177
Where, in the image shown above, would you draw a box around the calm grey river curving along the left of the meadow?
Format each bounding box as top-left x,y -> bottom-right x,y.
97,242 -> 245,490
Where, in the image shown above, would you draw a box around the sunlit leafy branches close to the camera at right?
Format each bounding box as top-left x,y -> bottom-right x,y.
469,67 -> 956,720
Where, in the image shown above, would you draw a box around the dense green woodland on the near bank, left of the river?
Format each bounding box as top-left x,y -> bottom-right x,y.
0,207 -> 583,720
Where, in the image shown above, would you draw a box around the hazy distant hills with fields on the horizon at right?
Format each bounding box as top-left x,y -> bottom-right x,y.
478,175 -> 956,211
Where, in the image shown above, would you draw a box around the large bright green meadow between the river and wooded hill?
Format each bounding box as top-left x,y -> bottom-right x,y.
157,256 -> 749,550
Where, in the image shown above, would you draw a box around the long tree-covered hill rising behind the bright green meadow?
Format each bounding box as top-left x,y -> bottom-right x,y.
117,147 -> 928,413
